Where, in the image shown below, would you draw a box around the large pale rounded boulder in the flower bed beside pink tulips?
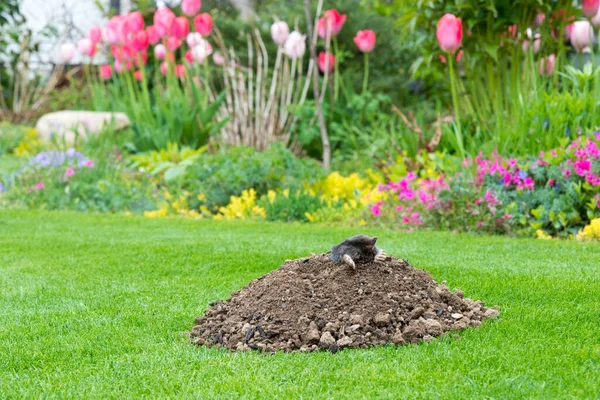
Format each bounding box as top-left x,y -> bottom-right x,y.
35,110 -> 131,144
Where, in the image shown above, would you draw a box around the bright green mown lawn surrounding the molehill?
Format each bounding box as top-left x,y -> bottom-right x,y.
0,211 -> 600,399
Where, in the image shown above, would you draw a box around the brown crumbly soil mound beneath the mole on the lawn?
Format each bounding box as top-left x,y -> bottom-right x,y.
190,253 -> 498,352
